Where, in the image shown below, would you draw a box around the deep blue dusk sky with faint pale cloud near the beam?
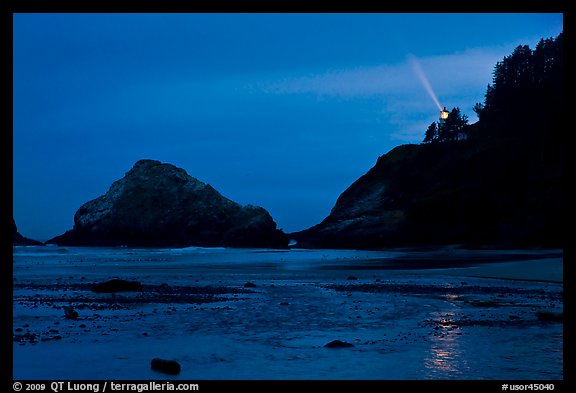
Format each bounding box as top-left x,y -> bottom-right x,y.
13,13 -> 563,240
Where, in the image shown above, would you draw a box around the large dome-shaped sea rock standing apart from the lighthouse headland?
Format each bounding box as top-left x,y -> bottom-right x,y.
47,160 -> 287,248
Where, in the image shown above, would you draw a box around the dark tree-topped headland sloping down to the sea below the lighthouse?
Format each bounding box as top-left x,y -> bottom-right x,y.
291,33 -> 571,248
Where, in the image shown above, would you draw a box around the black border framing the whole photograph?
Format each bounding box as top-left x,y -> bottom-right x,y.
0,0 -> 576,392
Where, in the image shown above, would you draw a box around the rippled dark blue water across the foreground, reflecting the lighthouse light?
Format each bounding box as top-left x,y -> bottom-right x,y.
13,246 -> 563,380
